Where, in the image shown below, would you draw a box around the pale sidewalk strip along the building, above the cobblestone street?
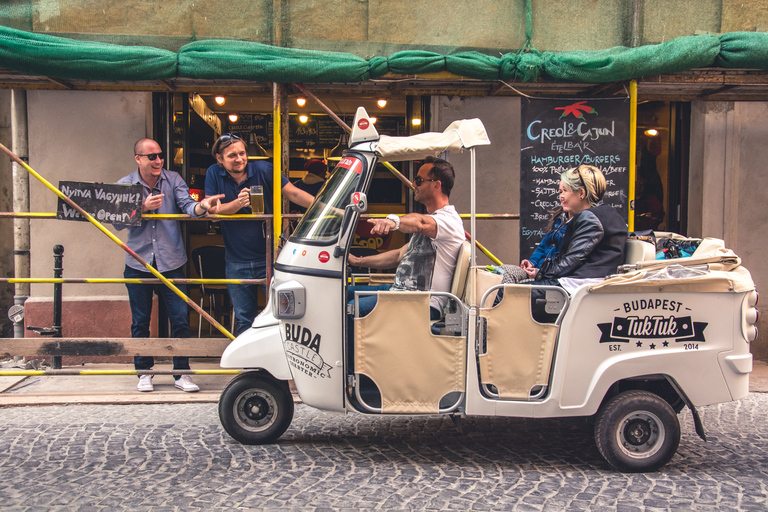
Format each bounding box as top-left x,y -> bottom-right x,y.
0,361 -> 768,407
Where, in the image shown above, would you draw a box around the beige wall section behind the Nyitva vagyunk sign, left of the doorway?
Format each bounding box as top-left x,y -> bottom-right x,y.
27,91 -> 151,297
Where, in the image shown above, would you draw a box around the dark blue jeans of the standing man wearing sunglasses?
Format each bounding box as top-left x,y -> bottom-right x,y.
123,265 -> 189,379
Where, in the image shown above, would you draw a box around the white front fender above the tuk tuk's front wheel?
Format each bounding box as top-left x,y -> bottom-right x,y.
220,321 -> 293,380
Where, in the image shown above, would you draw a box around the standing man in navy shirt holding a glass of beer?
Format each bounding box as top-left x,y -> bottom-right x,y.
205,133 -> 314,335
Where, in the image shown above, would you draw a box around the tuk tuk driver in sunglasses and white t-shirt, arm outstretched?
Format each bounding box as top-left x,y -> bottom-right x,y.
347,157 -> 466,322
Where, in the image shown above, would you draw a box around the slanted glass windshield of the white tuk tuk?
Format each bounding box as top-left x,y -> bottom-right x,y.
291,157 -> 362,241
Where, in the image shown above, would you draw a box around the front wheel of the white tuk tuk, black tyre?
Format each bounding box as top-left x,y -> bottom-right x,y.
219,372 -> 293,444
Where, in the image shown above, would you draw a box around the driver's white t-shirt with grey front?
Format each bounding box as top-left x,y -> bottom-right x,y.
391,205 -> 465,311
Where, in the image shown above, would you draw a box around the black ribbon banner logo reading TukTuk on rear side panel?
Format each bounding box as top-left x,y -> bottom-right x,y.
597,315 -> 708,346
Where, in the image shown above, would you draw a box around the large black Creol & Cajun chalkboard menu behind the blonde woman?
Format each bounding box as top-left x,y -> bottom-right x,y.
520,98 -> 629,260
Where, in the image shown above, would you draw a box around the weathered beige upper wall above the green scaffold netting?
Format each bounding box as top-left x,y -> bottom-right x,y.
9,0 -> 768,57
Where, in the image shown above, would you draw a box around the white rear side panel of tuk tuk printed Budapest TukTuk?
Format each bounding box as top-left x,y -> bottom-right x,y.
552,288 -> 749,414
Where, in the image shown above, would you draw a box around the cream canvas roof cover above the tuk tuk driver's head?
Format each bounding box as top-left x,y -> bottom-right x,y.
376,119 -> 491,162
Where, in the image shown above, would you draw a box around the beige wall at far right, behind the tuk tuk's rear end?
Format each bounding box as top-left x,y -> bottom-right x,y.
688,102 -> 768,360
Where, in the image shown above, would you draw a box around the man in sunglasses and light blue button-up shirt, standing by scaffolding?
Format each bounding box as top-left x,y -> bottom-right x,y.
114,139 -> 221,392
